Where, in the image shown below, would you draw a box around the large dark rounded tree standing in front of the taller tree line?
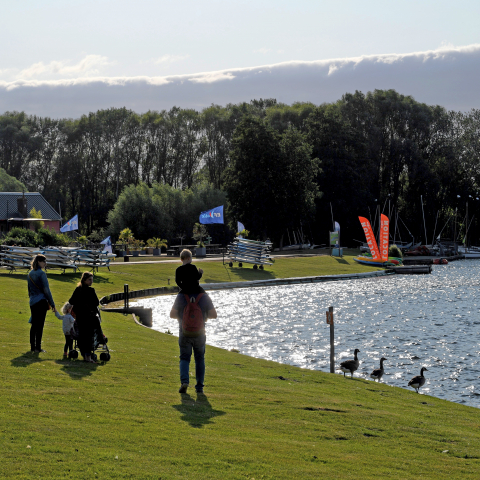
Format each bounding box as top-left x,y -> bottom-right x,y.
225,117 -> 319,241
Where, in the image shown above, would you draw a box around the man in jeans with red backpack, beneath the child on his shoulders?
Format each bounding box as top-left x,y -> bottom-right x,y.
170,289 -> 217,394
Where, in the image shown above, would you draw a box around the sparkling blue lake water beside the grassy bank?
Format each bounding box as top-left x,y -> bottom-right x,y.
134,260 -> 480,407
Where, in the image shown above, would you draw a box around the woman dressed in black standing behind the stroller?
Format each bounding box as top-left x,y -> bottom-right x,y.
68,272 -> 100,363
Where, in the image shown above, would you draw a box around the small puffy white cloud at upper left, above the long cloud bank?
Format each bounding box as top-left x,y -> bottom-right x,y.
15,55 -> 113,80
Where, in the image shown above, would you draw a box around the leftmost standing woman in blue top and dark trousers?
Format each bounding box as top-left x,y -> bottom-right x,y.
28,255 -> 55,353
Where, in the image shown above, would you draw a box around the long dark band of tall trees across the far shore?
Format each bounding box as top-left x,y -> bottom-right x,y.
0,90 -> 480,248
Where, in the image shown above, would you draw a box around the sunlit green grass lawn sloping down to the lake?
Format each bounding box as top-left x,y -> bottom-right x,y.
0,257 -> 480,480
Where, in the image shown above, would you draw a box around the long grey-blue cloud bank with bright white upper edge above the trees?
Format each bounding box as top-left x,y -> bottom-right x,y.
0,44 -> 480,118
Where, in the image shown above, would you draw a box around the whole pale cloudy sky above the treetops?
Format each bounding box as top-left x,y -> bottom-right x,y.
0,0 -> 480,118
